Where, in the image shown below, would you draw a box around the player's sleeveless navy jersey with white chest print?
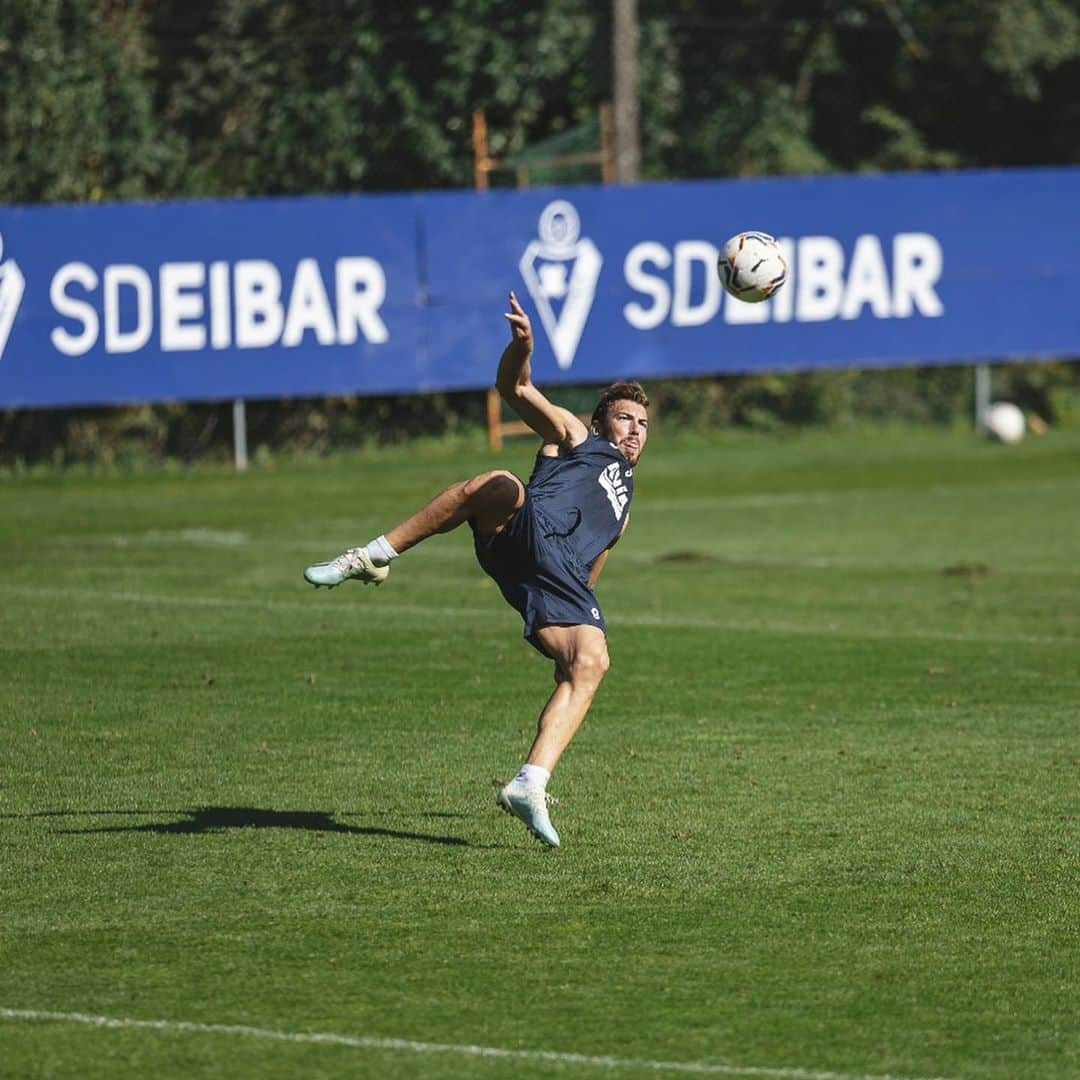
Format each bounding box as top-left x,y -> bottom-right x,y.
526,432 -> 634,567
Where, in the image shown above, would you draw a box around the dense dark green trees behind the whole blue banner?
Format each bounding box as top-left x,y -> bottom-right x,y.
0,0 -> 1080,464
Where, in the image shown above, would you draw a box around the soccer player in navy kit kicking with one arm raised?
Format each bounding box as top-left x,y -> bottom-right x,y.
303,293 -> 649,848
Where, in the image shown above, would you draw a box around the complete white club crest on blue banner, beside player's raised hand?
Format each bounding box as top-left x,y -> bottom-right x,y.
518,199 -> 604,370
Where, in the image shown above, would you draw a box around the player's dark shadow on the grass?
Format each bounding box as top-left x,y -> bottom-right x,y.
0,807 -> 473,848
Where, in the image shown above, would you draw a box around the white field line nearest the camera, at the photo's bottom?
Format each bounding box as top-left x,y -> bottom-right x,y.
0,1009 -> 942,1080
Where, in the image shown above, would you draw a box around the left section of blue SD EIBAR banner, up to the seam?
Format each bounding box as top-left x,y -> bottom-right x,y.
0,197 -> 428,407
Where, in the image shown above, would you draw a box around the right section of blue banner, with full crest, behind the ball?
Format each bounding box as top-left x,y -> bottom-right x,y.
420,170 -> 1080,393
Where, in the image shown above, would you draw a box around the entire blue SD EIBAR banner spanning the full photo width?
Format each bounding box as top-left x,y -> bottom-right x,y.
0,168 -> 1080,408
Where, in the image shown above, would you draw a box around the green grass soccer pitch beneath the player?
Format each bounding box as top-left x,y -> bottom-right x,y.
0,431 -> 1080,1080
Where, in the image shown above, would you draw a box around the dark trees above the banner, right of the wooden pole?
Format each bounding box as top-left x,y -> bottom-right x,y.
647,0 -> 1080,176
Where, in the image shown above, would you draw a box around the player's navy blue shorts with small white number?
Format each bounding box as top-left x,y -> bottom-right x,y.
473,491 -> 607,656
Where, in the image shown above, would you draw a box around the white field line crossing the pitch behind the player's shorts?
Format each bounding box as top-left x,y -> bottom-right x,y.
0,585 -> 1077,649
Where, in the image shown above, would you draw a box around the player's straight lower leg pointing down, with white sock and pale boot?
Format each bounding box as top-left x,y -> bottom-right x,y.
498,626 -> 610,848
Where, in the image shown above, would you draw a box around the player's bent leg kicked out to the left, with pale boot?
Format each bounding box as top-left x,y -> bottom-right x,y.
303,469 -> 525,589
